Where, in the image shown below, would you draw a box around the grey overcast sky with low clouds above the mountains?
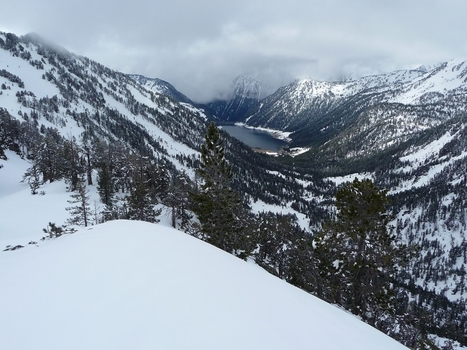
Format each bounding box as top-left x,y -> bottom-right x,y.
0,0 -> 467,102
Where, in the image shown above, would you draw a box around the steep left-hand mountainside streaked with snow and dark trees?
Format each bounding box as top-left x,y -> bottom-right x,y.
0,33 -> 205,162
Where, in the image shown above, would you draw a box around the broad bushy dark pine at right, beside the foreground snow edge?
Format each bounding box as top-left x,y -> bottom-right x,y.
314,179 -> 407,323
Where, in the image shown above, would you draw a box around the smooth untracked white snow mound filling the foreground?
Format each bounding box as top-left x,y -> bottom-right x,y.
0,221 -> 404,350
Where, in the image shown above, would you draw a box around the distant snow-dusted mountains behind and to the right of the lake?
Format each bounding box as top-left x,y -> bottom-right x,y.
210,61 -> 467,171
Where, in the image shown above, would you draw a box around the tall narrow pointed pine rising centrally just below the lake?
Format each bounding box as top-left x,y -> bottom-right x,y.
191,122 -> 251,257
